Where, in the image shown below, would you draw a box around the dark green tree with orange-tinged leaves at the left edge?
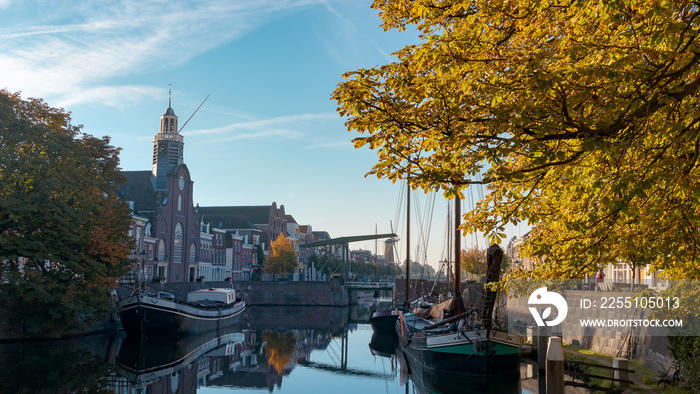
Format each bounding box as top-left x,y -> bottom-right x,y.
0,90 -> 131,336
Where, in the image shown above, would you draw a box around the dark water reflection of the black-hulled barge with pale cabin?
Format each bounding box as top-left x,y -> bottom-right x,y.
116,326 -> 245,385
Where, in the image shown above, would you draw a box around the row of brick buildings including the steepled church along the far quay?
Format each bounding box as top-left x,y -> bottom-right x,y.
117,103 -> 330,283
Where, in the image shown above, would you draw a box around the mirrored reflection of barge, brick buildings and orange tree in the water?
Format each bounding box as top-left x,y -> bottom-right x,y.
110,326 -> 330,393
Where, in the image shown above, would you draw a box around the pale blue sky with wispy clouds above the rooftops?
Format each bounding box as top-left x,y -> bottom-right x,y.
0,0 -> 518,266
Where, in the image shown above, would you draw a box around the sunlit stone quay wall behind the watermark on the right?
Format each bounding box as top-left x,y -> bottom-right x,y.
508,290 -> 673,371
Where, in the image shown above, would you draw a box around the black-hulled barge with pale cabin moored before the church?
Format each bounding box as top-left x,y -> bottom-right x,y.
118,289 -> 245,336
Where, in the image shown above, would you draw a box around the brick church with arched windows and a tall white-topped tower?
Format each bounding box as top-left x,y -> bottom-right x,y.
118,98 -> 201,282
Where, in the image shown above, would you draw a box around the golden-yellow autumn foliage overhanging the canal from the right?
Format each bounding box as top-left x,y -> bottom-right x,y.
332,0 -> 700,278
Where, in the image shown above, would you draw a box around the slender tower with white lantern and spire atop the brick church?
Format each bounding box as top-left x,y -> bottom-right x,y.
152,88 -> 185,190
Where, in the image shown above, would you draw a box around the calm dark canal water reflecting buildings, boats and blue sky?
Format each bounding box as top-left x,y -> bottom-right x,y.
0,301 -> 552,394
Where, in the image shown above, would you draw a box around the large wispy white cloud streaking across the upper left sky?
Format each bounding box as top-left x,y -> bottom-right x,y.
0,0 -> 322,106
